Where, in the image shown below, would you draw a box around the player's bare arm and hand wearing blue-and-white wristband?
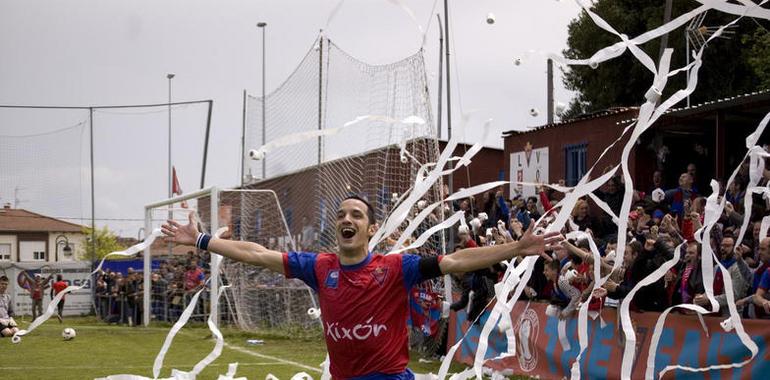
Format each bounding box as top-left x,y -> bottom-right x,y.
161,212 -> 284,274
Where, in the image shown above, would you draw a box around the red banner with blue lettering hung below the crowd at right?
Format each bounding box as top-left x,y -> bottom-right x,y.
449,302 -> 770,379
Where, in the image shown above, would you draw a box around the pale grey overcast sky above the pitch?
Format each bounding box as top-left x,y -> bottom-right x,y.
0,0 -> 579,236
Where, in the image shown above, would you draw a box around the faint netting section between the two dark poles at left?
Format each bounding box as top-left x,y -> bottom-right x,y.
90,103 -> 208,237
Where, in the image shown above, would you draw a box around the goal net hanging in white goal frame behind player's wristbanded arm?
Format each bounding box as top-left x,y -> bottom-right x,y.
145,188 -> 318,334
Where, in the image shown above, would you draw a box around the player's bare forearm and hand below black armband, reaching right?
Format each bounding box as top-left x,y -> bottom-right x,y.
439,223 -> 564,274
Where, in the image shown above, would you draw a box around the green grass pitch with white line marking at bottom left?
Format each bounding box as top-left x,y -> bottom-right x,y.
0,318 -> 465,380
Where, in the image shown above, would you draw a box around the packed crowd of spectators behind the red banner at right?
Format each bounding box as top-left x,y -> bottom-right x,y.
451,163 -> 770,320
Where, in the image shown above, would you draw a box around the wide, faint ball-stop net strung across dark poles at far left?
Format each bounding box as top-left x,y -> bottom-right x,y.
0,101 -> 209,237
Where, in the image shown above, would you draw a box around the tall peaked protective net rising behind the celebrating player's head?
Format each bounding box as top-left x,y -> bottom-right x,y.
243,36 -> 444,350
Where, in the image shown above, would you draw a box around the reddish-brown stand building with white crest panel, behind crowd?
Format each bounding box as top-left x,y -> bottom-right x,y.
503,90 -> 770,194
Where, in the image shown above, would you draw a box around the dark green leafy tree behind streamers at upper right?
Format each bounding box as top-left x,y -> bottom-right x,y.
562,0 -> 770,119
